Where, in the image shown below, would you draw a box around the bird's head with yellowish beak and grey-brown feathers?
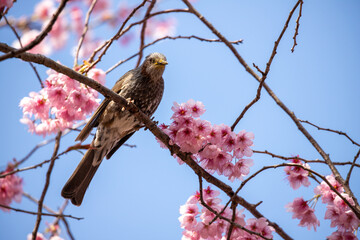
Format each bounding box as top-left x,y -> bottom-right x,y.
141,53 -> 168,79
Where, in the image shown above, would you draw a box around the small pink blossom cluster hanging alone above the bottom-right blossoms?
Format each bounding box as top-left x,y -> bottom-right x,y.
284,156 -> 310,190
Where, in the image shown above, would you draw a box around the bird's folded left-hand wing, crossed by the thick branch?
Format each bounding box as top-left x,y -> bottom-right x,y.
75,70 -> 133,142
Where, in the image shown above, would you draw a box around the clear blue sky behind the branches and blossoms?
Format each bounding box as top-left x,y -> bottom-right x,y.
0,0 -> 360,240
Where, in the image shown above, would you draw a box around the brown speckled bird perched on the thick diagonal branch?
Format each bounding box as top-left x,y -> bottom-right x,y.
61,52 -> 168,206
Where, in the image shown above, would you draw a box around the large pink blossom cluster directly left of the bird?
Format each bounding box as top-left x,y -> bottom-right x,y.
19,69 -> 105,136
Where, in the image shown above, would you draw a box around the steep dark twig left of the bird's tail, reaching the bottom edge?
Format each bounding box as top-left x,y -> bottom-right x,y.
32,131 -> 61,240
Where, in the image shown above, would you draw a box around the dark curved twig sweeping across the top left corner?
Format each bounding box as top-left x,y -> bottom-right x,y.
0,0 -> 69,62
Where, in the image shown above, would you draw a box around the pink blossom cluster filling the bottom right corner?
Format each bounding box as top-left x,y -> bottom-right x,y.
286,175 -> 360,240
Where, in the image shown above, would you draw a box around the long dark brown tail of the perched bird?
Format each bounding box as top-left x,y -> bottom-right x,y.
61,148 -> 104,206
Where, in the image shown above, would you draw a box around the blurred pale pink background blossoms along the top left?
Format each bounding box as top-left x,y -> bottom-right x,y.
11,0 -> 176,58
